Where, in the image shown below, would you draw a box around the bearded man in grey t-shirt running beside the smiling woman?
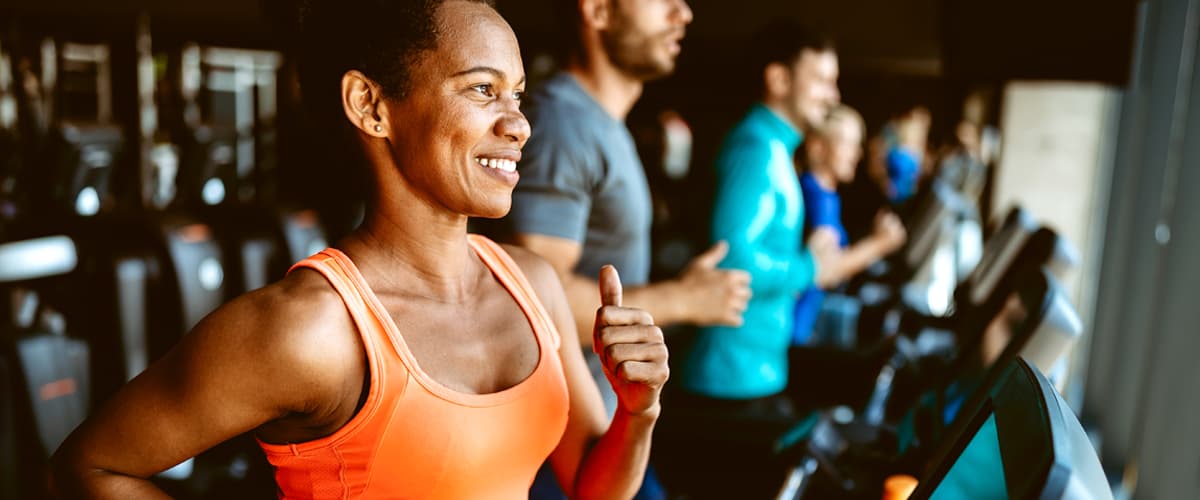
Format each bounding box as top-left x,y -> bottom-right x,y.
505,0 -> 750,414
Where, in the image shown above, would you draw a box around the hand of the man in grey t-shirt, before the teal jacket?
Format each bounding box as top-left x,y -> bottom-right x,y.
674,241 -> 750,326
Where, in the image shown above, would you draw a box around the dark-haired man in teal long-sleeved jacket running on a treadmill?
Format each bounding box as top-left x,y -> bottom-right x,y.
679,23 -> 840,410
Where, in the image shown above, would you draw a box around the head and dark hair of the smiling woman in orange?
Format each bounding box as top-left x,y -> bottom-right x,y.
300,1 -> 529,217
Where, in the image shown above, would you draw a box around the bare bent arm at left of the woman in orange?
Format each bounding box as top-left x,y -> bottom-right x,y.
53,278 -> 349,499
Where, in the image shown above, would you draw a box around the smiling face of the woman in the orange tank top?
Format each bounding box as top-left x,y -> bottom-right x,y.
385,0 -> 529,218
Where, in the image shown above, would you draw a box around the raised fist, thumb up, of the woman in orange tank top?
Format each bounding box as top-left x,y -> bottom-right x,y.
592,266 -> 671,417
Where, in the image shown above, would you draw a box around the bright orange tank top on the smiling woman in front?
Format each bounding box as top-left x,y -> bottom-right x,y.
259,235 -> 569,499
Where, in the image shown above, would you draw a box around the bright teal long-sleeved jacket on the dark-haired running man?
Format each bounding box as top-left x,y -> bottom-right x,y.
683,103 -> 816,399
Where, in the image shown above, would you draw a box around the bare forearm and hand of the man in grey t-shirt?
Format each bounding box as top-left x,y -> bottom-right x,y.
516,233 -> 750,347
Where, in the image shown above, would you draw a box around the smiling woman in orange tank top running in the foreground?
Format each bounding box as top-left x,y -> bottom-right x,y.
55,0 -> 667,499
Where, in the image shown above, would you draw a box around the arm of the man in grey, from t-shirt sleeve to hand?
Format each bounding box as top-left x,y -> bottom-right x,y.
508,107 -> 750,345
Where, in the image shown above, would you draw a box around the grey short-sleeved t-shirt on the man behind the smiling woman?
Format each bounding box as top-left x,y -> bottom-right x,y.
508,73 -> 653,285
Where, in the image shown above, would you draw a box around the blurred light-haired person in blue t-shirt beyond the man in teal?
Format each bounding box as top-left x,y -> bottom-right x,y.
792,104 -> 906,345
